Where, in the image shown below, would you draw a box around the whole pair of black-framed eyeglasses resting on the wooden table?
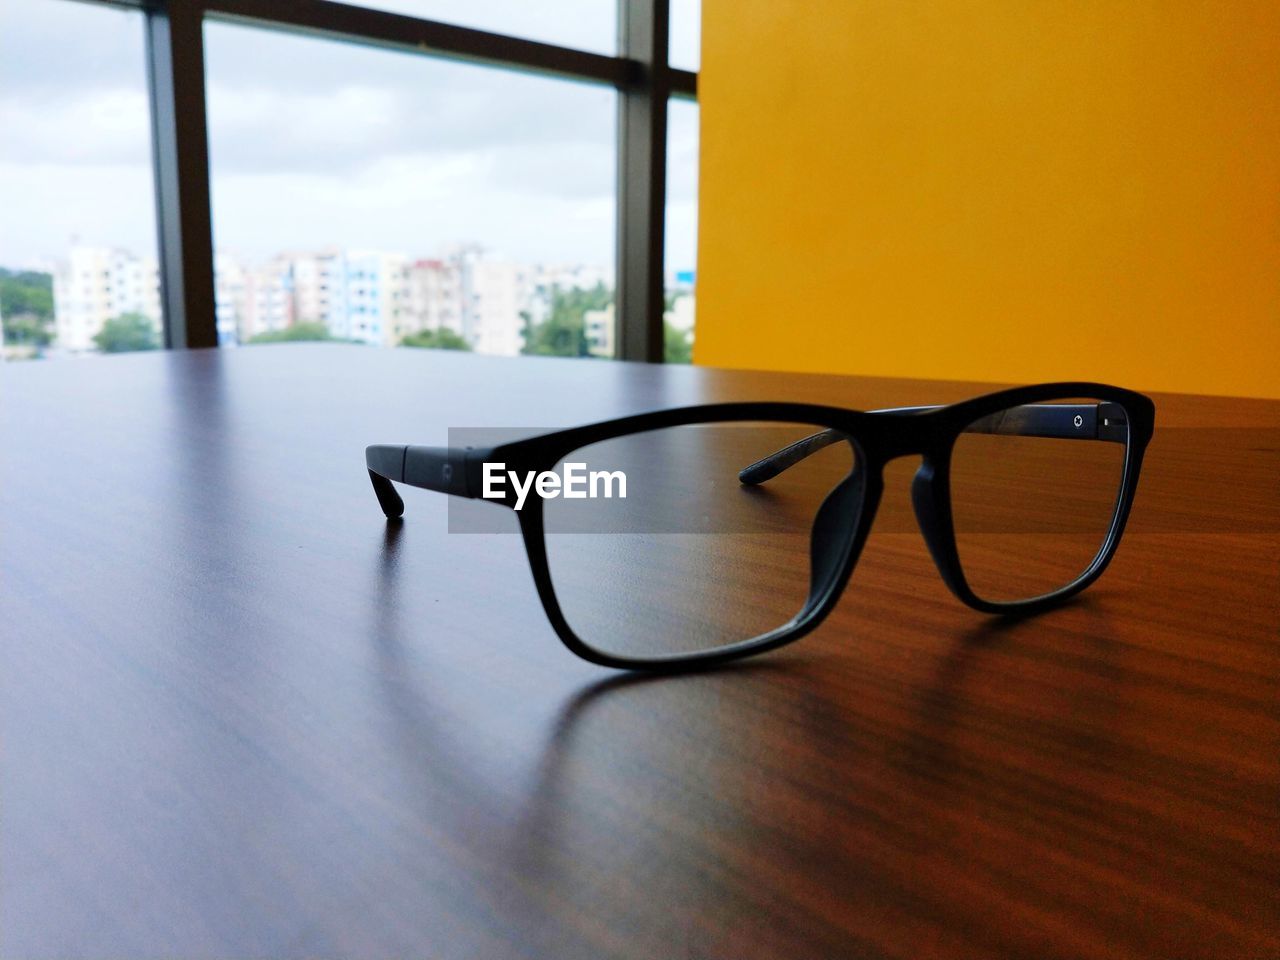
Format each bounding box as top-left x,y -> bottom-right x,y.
366,383 -> 1155,671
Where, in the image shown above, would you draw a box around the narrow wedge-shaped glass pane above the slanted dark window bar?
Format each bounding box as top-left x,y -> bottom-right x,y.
332,0 -> 618,55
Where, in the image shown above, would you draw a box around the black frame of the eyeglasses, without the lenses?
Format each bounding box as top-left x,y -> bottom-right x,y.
365,383 -> 1156,672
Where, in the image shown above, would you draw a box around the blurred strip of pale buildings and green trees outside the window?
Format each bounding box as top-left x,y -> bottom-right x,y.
0,243 -> 695,362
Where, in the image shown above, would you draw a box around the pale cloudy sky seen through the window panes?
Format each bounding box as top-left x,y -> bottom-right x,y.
0,0 -> 698,277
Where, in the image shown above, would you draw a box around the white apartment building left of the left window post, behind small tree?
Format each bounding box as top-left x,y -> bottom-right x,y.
54,244 -> 161,353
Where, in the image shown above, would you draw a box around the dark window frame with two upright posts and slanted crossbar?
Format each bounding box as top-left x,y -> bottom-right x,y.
85,0 -> 698,364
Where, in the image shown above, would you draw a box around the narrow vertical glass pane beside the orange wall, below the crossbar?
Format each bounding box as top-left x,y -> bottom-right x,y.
663,100 -> 698,364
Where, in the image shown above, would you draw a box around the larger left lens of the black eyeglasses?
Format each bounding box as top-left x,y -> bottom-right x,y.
543,422 -> 861,658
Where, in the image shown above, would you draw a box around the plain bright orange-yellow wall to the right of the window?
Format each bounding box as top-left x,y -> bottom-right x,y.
695,0 -> 1280,397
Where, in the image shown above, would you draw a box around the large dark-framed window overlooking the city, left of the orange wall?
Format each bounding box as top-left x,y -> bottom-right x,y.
0,0 -> 696,360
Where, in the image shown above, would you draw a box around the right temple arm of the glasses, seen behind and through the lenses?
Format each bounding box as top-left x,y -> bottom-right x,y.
737,403 -> 1128,486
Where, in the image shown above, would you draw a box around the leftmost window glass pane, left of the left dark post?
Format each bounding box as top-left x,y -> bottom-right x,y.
0,0 -> 161,360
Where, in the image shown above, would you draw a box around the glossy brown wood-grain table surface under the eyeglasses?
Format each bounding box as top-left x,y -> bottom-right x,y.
0,344 -> 1280,960
